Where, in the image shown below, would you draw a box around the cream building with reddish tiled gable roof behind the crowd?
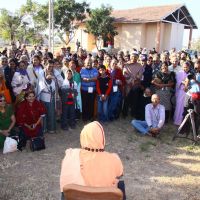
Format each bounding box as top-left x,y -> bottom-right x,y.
72,5 -> 197,51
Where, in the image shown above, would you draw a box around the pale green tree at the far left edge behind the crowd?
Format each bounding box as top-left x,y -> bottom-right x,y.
0,9 -> 21,42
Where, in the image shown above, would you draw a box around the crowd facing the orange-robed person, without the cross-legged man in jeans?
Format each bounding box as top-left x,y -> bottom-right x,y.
0,43 -> 200,148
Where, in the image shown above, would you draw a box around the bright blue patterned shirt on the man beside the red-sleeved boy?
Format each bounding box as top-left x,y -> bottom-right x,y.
80,68 -> 98,91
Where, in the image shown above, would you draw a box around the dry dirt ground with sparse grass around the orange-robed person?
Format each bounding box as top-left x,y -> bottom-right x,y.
0,118 -> 200,200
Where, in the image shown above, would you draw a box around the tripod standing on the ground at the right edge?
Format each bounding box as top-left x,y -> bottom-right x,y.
172,109 -> 198,142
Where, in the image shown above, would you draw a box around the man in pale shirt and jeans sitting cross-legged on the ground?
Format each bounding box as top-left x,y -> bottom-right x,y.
131,94 -> 165,137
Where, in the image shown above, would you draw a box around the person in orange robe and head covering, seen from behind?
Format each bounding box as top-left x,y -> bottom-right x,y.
60,121 -> 125,200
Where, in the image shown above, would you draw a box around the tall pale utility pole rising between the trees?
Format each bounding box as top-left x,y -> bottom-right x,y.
49,0 -> 54,53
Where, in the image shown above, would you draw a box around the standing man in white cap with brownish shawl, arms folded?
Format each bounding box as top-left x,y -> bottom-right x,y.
122,51 -> 143,117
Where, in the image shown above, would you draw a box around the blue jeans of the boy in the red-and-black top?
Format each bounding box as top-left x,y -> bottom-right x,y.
98,96 -> 108,122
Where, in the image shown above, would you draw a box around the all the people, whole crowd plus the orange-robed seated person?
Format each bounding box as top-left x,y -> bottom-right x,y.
0,43 -> 200,199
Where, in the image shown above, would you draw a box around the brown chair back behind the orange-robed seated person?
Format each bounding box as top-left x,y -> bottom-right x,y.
63,184 -> 123,200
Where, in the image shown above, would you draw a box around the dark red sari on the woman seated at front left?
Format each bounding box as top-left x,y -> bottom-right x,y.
16,100 -> 46,138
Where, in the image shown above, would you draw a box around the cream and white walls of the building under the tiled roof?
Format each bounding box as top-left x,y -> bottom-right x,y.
72,23 -> 184,51
